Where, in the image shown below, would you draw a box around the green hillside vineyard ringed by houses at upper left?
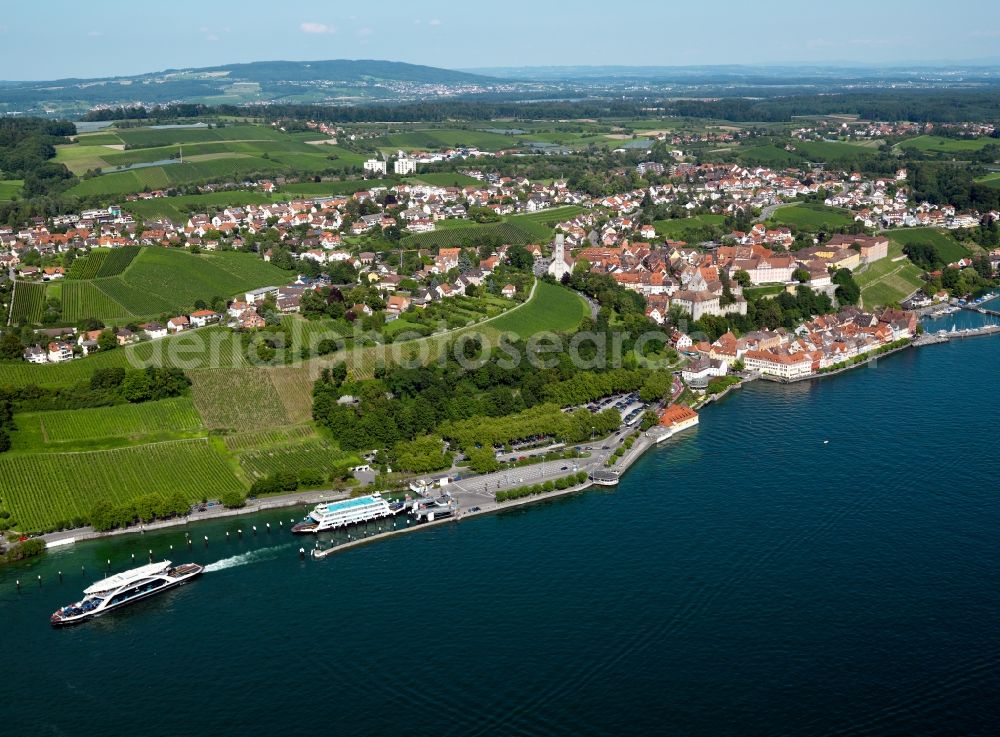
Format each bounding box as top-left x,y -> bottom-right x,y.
35,246 -> 288,324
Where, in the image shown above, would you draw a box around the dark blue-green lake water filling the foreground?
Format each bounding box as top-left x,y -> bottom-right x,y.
0,330 -> 1000,736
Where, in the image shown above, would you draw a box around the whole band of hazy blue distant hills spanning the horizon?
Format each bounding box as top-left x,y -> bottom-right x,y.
0,59 -> 1000,119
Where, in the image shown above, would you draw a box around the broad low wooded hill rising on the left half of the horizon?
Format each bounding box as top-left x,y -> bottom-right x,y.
0,59 -> 500,116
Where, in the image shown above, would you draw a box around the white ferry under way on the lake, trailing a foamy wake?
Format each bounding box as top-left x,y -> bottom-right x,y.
49,560 -> 205,627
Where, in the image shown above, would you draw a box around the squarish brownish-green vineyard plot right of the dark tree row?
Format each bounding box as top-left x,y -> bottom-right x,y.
189,367 -> 290,430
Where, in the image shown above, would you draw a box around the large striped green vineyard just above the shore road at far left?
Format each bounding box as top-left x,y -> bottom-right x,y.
0,439 -> 246,531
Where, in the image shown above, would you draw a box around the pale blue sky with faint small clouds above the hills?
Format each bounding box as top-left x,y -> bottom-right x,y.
0,0 -> 1000,80
